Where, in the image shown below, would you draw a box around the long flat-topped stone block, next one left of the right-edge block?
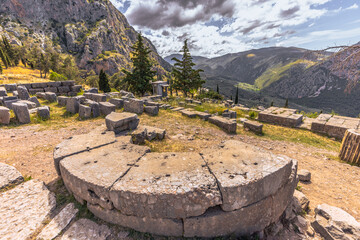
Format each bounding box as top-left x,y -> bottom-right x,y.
258,107 -> 303,127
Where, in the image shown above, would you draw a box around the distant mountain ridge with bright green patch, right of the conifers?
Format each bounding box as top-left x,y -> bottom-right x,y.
165,47 -> 360,116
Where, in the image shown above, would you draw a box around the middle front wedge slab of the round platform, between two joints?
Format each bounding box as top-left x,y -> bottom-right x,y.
110,153 -> 221,218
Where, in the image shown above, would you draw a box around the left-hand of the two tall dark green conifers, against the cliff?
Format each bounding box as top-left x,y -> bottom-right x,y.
123,33 -> 156,95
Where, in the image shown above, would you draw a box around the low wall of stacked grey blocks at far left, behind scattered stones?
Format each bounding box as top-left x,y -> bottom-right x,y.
0,81 -> 82,96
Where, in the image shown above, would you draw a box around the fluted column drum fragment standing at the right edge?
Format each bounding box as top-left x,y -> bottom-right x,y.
339,129 -> 360,166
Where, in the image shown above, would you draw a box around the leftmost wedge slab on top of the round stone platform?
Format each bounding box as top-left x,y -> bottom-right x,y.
54,130 -> 116,175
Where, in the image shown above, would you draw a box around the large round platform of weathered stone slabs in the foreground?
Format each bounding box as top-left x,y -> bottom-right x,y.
54,128 -> 297,237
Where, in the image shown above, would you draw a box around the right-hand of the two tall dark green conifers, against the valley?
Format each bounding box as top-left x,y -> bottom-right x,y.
172,40 -> 205,97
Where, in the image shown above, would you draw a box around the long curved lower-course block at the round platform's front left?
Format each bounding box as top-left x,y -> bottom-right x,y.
87,203 -> 183,236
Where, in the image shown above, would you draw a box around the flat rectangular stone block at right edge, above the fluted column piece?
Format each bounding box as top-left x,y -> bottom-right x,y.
311,114 -> 360,140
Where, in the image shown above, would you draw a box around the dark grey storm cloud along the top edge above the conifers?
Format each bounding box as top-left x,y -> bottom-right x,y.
127,0 -> 235,30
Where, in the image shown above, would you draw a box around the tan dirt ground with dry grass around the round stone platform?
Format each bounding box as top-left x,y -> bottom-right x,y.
0,112 -> 360,221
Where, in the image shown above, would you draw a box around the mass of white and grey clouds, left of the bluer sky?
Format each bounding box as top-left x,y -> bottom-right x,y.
111,0 -> 338,57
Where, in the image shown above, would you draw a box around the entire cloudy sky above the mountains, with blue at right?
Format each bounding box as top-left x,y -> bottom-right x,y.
111,0 -> 360,57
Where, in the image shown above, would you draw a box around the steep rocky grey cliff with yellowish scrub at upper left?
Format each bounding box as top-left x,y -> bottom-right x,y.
0,0 -> 170,74
